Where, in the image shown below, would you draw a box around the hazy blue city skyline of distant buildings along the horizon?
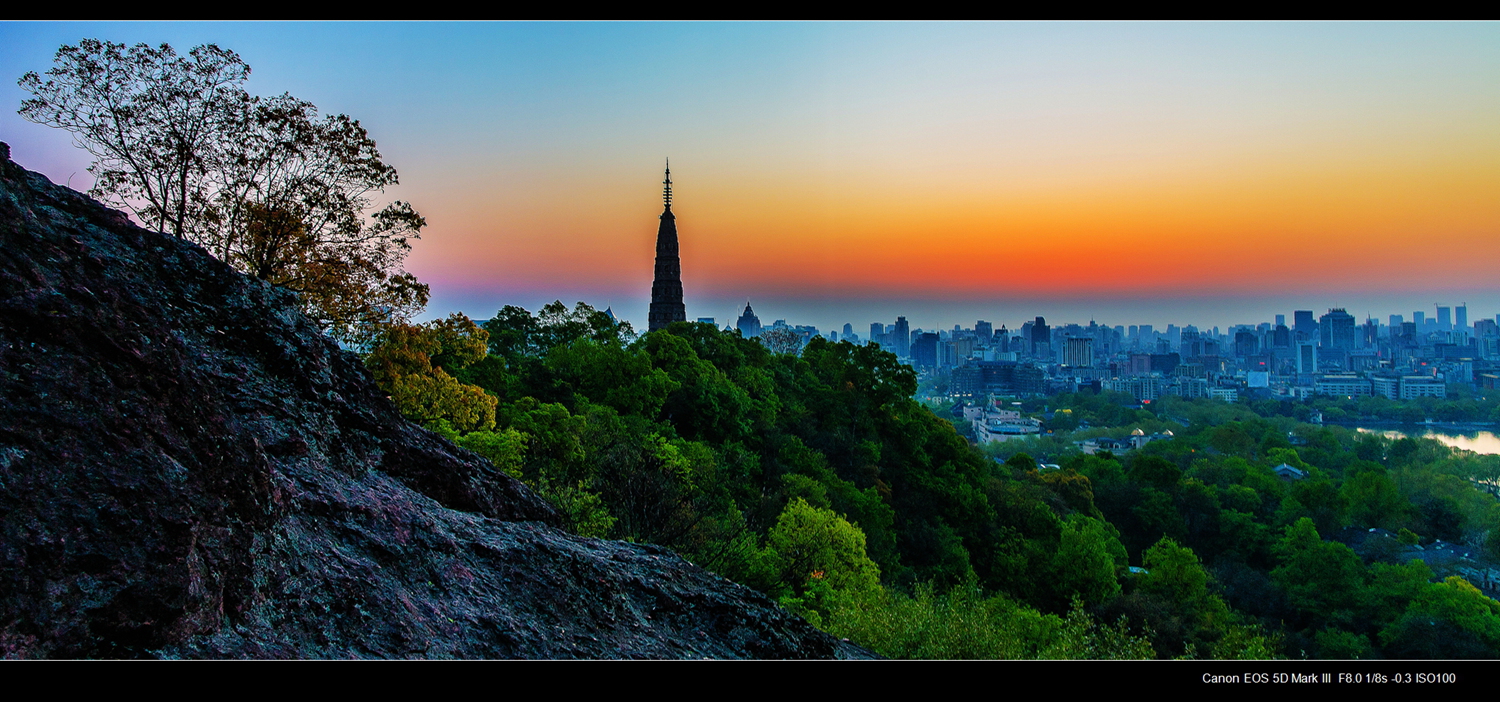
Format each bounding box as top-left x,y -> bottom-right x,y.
705,303 -> 1500,411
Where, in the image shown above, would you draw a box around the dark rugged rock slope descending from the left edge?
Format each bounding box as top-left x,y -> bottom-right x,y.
0,144 -> 864,659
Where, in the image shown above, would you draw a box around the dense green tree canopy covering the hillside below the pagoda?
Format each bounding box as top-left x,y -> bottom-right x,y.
368,303 -> 1500,659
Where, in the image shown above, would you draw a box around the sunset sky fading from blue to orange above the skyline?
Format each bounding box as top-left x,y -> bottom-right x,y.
0,23 -> 1500,335
